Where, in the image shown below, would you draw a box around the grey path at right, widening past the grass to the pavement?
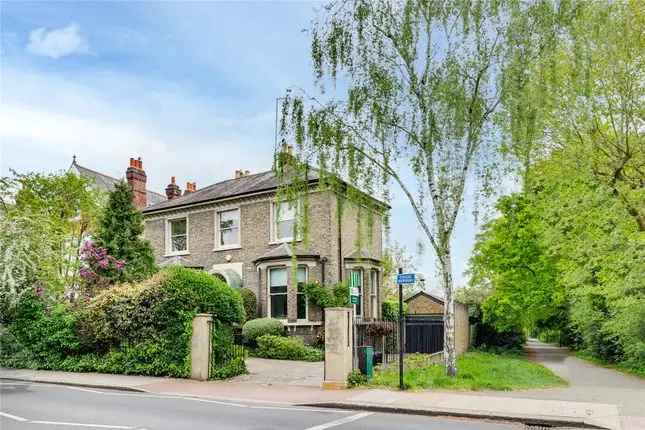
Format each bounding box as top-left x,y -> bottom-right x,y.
476,339 -> 645,430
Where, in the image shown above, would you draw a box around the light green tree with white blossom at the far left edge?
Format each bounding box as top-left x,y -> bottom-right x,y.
0,172 -> 102,322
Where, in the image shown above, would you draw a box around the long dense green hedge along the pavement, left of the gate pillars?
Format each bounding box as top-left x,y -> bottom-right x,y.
0,267 -> 244,377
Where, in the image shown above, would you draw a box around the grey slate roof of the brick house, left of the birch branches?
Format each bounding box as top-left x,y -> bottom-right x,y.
143,170 -> 318,213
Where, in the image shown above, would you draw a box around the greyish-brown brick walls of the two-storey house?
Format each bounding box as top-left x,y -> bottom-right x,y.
144,191 -> 382,330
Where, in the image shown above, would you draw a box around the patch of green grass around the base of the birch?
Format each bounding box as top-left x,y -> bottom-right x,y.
369,352 -> 567,390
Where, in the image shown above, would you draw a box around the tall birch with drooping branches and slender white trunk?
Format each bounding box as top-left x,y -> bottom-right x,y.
278,0 -> 525,375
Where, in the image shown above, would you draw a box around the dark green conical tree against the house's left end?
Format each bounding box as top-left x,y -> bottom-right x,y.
96,181 -> 156,281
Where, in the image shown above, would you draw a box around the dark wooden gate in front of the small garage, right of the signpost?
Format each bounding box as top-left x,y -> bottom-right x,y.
405,315 -> 443,354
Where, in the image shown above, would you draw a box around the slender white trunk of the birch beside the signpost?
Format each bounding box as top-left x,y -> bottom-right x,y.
439,241 -> 457,376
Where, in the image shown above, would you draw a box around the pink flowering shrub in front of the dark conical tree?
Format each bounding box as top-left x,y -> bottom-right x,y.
78,240 -> 125,296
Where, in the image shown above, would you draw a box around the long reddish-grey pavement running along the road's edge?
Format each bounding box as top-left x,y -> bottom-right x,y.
0,369 -> 624,430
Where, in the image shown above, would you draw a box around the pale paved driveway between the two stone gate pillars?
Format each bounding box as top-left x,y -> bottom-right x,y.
230,357 -> 325,387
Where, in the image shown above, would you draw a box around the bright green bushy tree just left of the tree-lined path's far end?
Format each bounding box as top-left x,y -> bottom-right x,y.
470,194 -> 564,331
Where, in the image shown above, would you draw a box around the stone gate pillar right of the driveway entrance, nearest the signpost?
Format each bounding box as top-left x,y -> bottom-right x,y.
323,308 -> 354,390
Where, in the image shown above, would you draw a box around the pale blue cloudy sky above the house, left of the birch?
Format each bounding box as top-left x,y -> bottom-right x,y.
0,2 -> 512,283
